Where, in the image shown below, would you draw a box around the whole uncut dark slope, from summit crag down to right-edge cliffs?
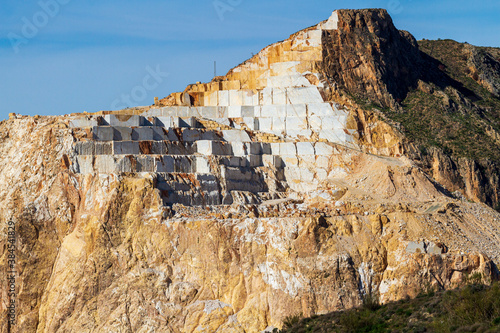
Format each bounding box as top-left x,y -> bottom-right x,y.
324,24 -> 500,208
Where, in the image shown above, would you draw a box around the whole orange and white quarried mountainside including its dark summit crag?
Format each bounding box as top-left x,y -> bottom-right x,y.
0,10 -> 500,332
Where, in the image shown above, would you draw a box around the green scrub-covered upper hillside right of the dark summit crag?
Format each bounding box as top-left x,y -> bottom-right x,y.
376,39 -> 500,163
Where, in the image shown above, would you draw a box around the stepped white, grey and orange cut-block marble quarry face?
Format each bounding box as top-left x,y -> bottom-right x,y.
70,12 -> 357,206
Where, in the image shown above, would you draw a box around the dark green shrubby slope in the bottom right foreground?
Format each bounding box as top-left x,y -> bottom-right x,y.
275,282 -> 500,333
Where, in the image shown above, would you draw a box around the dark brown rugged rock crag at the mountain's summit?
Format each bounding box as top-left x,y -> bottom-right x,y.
322,9 -> 420,107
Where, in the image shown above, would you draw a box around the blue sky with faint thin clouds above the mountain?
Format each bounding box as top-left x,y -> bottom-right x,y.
0,0 -> 500,119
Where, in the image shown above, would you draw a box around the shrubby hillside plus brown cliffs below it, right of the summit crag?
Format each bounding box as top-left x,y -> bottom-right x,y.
404,40 -> 500,208
